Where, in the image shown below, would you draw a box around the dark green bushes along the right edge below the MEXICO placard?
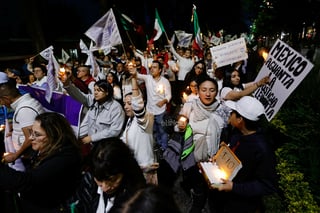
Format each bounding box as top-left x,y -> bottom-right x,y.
270,63 -> 320,213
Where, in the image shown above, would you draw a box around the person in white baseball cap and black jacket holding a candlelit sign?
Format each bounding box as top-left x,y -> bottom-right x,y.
208,96 -> 277,213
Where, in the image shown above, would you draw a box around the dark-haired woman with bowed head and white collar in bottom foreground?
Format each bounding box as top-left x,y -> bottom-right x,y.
92,138 -> 146,213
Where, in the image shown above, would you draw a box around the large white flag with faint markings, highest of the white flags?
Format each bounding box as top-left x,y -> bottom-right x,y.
85,8 -> 122,50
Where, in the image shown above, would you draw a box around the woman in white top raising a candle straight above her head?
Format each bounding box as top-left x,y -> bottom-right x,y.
120,65 -> 158,182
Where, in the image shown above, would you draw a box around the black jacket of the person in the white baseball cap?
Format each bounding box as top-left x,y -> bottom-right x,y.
211,132 -> 277,213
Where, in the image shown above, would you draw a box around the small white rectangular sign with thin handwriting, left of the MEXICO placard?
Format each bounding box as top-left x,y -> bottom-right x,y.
210,37 -> 248,67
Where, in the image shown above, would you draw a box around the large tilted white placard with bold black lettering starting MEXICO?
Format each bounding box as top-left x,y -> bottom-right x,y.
254,39 -> 313,121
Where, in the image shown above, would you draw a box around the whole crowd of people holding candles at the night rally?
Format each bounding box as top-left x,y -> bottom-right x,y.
0,42 -> 277,213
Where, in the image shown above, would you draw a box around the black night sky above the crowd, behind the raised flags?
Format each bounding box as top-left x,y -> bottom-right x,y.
0,0 -> 320,56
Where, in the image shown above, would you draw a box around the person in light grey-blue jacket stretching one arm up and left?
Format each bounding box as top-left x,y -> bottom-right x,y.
59,71 -> 125,149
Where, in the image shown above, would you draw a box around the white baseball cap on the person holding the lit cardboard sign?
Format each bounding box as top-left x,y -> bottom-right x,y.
225,96 -> 264,121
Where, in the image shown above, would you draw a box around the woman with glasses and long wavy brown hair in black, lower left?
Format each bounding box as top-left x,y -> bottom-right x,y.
0,112 -> 82,213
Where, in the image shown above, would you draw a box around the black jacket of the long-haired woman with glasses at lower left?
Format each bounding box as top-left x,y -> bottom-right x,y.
0,146 -> 81,213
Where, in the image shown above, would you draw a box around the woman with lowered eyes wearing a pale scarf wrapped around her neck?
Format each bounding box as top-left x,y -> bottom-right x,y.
180,76 -> 230,213
